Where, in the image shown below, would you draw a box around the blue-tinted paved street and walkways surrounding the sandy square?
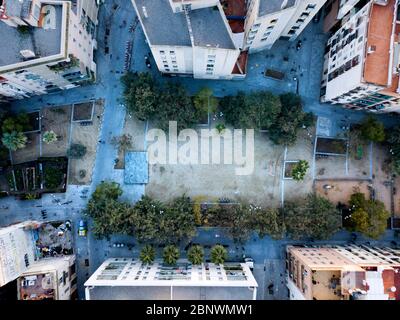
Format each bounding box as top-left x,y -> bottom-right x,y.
0,0 -> 397,299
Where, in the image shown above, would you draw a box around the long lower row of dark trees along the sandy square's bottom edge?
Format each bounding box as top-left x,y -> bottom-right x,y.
86,182 -> 341,244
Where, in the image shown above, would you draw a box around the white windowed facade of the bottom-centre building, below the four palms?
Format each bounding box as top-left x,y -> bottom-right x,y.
85,258 -> 258,287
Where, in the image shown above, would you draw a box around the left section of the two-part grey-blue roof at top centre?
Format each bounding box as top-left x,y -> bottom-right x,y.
134,0 -> 192,46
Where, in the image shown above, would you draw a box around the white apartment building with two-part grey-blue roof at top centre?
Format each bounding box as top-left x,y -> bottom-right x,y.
132,0 -> 245,79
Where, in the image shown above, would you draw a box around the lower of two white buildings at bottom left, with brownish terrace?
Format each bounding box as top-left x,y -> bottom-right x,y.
17,255 -> 77,300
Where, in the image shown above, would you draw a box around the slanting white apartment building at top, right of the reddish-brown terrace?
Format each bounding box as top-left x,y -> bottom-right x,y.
244,0 -> 326,53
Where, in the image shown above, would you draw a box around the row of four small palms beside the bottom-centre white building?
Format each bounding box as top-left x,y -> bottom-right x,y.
139,244 -> 228,265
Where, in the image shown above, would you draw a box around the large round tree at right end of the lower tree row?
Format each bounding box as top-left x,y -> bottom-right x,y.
283,193 -> 341,239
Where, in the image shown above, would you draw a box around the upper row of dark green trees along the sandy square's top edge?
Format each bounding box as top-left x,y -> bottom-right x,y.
121,73 -> 314,145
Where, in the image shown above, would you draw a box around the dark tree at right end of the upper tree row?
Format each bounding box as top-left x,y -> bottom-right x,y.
269,93 -> 314,145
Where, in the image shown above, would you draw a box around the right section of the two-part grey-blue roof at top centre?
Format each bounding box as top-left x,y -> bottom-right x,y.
189,6 -> 235,50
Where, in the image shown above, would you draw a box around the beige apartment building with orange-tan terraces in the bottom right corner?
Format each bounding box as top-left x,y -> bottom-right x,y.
286,245 -> 400,300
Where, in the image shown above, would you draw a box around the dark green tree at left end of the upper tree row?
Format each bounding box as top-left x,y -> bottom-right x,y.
121,72 -> 159,121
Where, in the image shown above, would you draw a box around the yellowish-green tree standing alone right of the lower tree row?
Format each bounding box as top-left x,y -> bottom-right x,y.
348,192 -> 390,239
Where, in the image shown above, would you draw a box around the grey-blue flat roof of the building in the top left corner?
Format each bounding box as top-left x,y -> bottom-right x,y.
0,1 -> 63,67
